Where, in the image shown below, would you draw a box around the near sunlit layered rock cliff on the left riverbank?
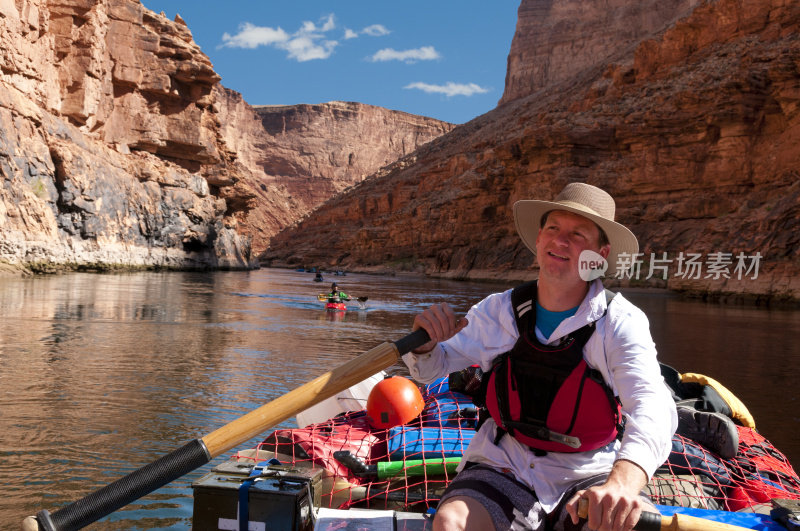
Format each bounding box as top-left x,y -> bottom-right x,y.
0,0 -> 253,269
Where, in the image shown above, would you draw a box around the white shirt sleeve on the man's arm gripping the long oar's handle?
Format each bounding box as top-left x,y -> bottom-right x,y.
403,290 -> 517,384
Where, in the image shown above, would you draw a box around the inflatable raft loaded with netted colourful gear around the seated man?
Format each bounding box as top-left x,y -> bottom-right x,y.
193,378 -> 800,530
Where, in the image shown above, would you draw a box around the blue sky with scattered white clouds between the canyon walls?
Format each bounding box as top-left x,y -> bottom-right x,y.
142,0 -> 520,123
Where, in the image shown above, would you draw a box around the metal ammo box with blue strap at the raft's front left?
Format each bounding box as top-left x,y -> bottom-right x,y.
192,461 -> 323,531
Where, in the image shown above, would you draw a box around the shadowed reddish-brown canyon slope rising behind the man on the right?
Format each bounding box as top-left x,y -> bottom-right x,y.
264,0 -> 800,300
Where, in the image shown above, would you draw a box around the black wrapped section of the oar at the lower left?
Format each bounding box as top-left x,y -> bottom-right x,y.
36,439 -> 211,531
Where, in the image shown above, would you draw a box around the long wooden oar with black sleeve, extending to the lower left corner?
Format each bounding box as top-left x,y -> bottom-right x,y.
22,328 -> 430,531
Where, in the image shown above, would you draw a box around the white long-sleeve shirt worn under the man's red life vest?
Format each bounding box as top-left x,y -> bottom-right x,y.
403,280 -> 678,512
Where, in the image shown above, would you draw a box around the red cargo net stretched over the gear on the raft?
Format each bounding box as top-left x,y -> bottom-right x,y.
234,379 -> 800,512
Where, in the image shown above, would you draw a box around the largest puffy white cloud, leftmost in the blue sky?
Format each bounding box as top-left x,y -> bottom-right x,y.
220,13 -> 339,62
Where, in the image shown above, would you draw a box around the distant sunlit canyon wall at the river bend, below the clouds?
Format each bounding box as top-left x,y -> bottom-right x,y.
219,96 -> 454,252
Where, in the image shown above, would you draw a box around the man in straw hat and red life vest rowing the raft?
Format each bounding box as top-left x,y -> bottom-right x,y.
404,183 -> 677,531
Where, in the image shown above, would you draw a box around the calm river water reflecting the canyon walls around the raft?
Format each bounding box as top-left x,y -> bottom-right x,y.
0,269 -> 800,530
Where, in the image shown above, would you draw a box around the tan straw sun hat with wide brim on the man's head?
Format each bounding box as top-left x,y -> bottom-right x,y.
514,183 -> 639,276
